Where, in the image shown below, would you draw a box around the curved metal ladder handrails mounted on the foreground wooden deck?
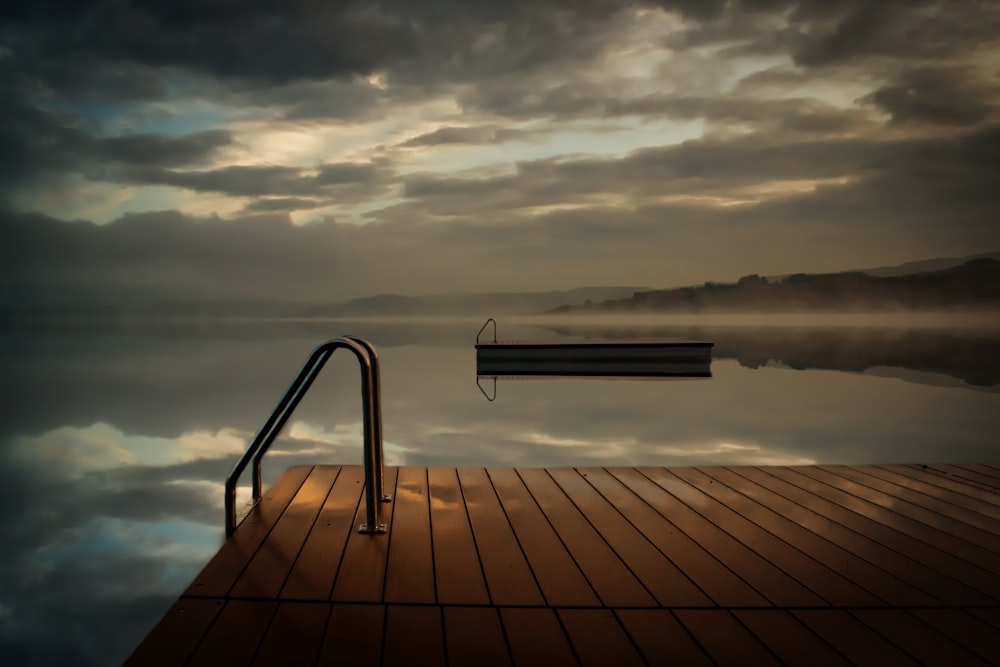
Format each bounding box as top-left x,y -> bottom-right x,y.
225,336 -> 389,537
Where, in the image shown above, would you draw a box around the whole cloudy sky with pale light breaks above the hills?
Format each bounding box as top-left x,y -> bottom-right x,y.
0,0 -> 1000,302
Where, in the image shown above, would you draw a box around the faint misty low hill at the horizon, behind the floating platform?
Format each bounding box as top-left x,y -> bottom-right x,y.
298,287 -> 649,317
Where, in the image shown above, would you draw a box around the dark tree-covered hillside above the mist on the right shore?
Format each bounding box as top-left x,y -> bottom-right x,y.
549,258 -> 1000,314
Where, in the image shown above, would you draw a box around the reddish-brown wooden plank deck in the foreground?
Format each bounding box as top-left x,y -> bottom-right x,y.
129,464 -> 1000,667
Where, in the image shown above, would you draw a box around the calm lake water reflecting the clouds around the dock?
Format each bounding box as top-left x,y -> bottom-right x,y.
0,322 -> 1000,665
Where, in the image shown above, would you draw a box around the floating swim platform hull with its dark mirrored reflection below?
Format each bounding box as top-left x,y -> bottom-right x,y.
476,340 -> 713,377
